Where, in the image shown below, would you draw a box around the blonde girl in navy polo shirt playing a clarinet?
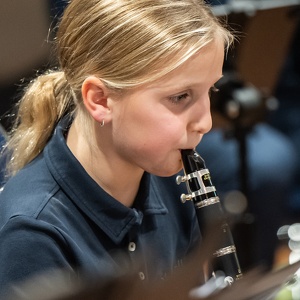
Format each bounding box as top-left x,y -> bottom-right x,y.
0,0 -> 232,296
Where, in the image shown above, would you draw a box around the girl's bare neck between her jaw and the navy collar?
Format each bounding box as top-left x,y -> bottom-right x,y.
67,119 -> 144,207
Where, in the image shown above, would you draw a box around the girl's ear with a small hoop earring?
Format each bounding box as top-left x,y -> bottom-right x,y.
81,76 -> 110,123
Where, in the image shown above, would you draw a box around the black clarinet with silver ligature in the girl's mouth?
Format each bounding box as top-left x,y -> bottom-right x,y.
176,149 -> 242,285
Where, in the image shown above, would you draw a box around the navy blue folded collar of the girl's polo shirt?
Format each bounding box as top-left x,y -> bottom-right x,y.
45,117 -> 168,243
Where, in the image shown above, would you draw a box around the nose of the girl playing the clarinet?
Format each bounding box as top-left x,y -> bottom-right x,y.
190,96 -> 212,134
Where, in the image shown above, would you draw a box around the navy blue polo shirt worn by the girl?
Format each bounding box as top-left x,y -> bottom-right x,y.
0,118 -> 199,291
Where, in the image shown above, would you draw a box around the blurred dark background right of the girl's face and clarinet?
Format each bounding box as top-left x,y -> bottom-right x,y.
198,0 -> 300,269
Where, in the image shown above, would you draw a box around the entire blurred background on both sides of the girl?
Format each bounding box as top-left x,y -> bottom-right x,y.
0,0 -> 300,282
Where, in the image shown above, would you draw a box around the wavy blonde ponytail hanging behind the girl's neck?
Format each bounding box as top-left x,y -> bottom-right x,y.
6,71 -> 75,175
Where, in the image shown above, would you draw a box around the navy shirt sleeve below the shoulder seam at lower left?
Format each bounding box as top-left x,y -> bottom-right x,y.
0,216 -> 72,294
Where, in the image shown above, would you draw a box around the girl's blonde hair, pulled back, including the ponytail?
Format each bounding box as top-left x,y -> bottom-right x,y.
8,0 -> 233,174
